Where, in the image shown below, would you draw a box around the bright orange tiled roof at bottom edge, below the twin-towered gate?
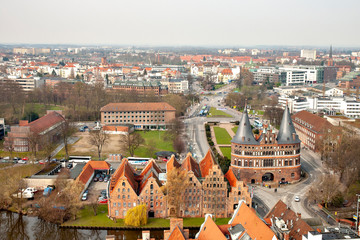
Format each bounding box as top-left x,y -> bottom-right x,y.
230,201 -> 275,240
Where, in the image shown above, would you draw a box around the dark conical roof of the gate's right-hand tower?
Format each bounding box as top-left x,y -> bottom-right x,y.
276,106 -> 300,144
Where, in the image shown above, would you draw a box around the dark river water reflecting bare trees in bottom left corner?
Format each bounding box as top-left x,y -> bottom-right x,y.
0,211 -> 197,240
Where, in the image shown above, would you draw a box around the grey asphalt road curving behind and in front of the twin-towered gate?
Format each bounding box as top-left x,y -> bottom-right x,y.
184,81 -> 325,218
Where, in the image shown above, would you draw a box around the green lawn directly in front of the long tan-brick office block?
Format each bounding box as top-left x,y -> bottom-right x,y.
135,131 -> 175,157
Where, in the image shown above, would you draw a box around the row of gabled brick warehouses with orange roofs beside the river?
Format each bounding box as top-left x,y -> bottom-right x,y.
108,150 -> 251,218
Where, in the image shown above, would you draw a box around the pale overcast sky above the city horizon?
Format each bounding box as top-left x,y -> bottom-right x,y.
0,0 -> 360,47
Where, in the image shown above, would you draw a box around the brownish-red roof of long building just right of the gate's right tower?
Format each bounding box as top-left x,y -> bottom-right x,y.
291,110 -> 332,133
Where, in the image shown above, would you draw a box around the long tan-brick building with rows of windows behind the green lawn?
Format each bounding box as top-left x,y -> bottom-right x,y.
100,102 -> 176,130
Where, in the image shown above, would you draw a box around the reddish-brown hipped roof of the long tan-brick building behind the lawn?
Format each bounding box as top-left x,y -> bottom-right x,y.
100,102 -> 176,112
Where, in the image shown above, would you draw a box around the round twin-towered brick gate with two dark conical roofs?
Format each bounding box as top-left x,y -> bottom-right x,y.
231,107 -> 301,183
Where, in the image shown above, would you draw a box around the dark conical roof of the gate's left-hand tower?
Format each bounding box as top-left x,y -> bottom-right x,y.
231,106 -> 259,145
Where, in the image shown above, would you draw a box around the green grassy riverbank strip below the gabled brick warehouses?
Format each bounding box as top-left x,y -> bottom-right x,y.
61,205 -> 230,230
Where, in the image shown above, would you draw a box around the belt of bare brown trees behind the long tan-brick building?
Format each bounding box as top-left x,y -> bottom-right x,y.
0,80 -> 199,124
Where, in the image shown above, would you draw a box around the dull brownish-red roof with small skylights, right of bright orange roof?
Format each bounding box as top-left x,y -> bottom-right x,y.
265,200 -> 314,240
